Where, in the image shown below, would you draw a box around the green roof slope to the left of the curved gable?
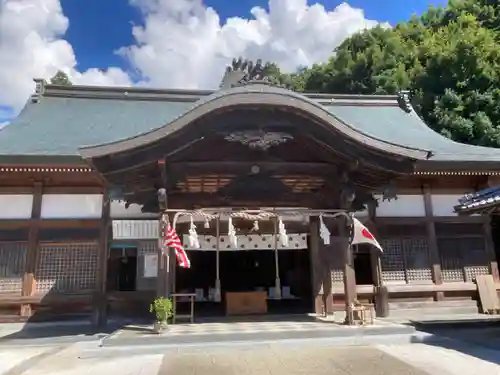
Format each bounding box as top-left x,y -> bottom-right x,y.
0,97 -> 192,155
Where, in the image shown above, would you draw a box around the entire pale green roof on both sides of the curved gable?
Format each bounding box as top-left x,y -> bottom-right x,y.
0,81 -> 500,162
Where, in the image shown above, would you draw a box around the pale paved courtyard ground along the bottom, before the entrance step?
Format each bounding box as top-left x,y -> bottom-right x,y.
0,343 -> 500,375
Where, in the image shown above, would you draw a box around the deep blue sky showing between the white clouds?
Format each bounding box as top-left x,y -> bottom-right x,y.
62,0 -> 446,70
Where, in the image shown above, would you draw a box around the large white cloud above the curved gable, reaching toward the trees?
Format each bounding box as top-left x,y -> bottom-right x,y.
121,0 -> 377,88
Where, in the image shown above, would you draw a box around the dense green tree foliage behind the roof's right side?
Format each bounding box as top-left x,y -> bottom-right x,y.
278,0 -> 500,147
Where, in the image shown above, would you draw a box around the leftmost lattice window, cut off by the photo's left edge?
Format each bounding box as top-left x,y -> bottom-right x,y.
0,242 -> 28,293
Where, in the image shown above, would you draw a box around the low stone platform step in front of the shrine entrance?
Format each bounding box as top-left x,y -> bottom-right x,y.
102,320 -> 415,349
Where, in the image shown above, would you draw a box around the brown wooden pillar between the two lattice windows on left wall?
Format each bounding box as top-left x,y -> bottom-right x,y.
20,182 -> 43,318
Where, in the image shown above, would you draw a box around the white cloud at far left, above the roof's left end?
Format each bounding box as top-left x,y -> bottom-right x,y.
0,0 -> 130,110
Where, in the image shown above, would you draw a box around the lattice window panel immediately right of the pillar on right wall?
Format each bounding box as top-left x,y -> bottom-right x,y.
438,238 -> 464,282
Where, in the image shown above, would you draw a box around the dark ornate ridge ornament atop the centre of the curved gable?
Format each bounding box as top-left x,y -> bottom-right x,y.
219,57 -> 282,89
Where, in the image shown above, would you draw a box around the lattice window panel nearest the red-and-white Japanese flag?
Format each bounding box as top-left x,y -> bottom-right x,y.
380,239 -> 406,283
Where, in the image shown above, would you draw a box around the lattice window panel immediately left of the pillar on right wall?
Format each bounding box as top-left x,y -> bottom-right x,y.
402,238 -> 432,283
